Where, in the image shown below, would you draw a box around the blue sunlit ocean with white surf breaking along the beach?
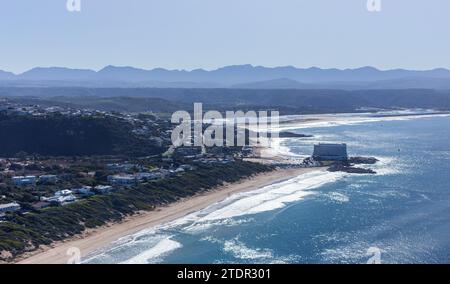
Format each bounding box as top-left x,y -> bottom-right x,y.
84,113 -> 450,263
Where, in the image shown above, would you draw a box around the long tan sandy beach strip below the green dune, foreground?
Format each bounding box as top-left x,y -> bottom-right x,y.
13,168 -> 324,264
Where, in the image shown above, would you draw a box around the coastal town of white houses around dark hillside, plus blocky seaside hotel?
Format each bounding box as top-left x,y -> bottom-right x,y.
0,99 -> 375,215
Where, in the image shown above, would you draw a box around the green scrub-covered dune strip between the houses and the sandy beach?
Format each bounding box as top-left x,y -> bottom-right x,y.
0,161 -> 270,255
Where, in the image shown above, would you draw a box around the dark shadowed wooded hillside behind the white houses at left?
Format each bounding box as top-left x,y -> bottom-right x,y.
0,114 -> 163,157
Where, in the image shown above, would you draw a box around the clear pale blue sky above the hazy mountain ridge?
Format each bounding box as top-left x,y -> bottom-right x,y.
0,0 -> 450,73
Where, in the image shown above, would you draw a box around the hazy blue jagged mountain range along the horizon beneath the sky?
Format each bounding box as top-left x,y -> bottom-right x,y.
0,65 -> 450,89
